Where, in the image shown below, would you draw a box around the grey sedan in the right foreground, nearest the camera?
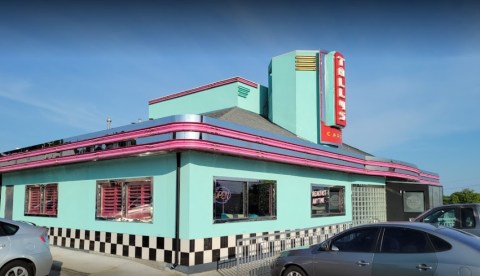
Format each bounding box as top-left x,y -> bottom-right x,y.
271,222 -> 480,276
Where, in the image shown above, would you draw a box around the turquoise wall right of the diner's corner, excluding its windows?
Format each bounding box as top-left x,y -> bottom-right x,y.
180,152 -> 384,239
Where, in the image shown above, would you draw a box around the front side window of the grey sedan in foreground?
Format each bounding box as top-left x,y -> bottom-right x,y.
331,227 -> 380,252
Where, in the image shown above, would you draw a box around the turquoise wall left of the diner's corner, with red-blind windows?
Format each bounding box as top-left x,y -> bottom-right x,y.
0,154 -> 176,237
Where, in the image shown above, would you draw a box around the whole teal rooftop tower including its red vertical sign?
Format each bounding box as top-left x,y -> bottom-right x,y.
269,50 -> 347,146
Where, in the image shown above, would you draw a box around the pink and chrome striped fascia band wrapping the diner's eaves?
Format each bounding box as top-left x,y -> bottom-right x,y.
0,115 -> 440,185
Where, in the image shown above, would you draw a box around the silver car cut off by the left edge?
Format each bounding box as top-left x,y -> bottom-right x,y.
0,218 -> 53,276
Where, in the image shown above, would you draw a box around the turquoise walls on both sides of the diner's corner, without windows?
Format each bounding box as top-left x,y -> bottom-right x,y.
0,151 -> 384,239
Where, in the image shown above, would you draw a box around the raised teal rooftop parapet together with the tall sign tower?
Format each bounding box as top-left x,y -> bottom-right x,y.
149,50 -> 347,147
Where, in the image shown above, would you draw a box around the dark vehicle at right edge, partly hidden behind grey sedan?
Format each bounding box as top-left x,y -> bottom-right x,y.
411,203 -> 480,236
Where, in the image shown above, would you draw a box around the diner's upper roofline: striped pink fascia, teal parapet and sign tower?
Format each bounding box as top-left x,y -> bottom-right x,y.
0,51 -> 440,185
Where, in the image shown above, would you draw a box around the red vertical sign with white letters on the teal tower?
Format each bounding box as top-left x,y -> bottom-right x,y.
318,51 -> 347,145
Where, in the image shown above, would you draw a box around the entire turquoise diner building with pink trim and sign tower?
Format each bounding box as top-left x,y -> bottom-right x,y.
0,50 -> 442,271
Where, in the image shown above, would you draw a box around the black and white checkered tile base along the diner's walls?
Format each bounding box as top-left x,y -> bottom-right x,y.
49,224 -> 348,266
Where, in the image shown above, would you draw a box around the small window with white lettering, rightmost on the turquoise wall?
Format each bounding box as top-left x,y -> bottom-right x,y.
310,184 -> 346,218
